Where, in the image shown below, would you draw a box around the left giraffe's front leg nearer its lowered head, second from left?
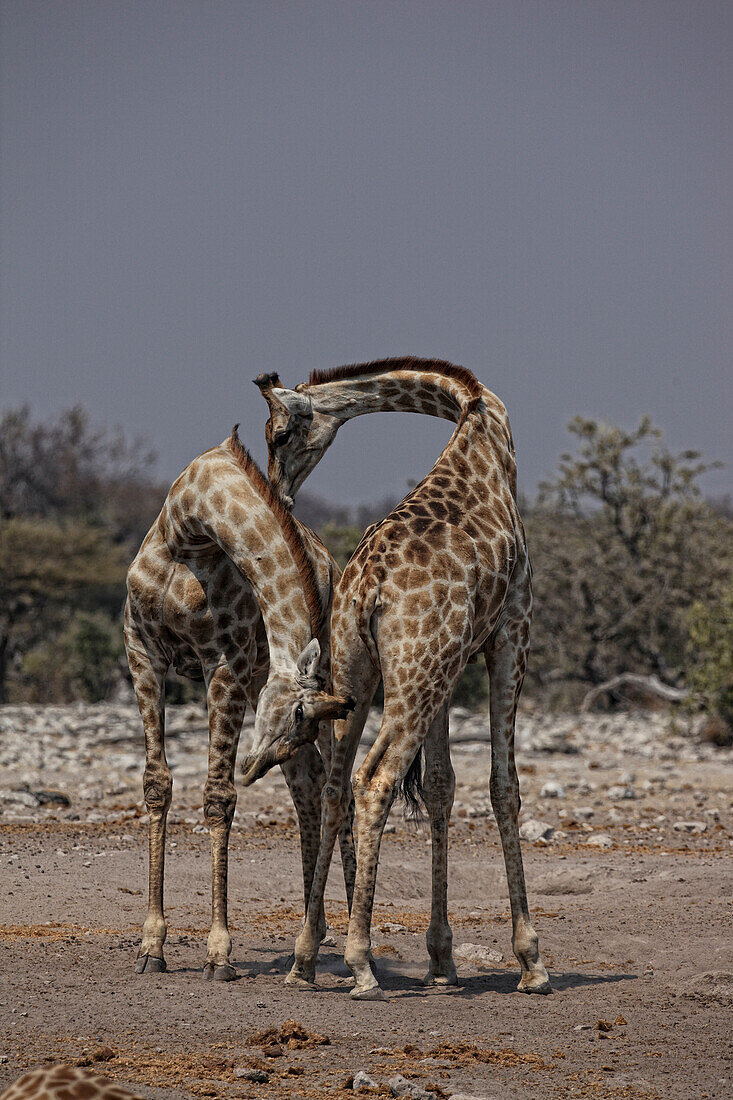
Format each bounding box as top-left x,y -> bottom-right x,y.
204,664 -> 247,981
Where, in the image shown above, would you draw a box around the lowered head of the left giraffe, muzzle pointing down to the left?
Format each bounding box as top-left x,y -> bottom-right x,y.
242,638 -> 354,787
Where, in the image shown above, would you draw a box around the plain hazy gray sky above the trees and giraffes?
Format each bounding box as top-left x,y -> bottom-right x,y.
0,0 -> 733,502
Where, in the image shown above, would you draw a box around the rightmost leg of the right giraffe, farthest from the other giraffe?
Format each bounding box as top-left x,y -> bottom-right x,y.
485,626 -> 553,993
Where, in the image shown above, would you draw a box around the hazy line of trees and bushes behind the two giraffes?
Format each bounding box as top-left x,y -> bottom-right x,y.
0,407 -> 733,723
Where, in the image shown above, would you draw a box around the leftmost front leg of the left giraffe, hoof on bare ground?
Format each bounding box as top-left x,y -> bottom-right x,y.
125,642 -> 173,974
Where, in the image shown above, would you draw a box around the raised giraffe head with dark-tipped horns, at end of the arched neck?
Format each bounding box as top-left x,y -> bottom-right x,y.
254,374 -> 342,508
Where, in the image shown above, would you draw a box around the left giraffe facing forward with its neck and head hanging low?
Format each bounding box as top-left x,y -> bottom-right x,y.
124,429 -> 355,981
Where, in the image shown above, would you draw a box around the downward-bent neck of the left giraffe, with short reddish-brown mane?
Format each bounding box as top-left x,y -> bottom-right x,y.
163,440 -> 320,670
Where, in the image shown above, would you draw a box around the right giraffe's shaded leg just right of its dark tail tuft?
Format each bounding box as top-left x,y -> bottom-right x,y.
423,704 -> 458,986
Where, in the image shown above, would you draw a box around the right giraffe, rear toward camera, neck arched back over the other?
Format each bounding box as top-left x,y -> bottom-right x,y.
250,359 -> 551,999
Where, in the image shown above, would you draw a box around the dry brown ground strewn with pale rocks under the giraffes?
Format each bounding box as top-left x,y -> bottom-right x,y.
0,704 -> 733,1100
